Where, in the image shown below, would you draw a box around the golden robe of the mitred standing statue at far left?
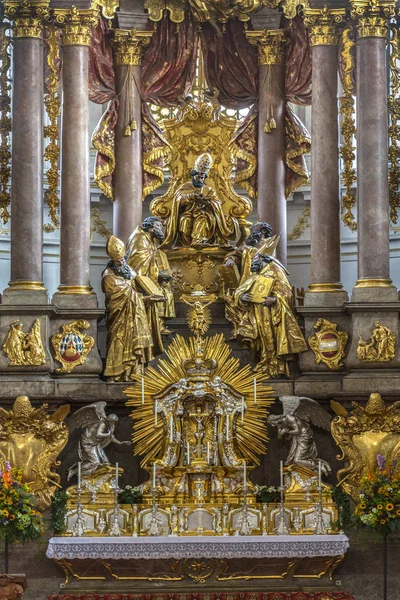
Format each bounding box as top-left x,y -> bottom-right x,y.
102,267 -> 153,381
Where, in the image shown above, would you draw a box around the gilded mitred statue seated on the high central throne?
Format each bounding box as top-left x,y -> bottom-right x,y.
163,152 -> 239,248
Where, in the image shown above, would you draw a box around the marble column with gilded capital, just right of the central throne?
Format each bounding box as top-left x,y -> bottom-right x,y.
246,29 -> 288,264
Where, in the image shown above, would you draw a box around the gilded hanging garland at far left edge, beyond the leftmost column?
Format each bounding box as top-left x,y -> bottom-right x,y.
0,17 -> 12,223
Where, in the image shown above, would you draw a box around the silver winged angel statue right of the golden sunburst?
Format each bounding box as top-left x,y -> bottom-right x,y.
268,396 -> 332,475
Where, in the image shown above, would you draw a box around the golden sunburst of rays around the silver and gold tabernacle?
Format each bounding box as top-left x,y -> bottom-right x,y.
124,334 -> 273,468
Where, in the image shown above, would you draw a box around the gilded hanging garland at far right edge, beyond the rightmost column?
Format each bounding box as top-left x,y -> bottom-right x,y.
388,24 -> 400,224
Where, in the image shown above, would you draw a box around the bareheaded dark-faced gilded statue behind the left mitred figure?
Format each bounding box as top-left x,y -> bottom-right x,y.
126,217 -> 175,343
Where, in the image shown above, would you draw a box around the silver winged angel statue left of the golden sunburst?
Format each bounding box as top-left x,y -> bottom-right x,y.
67,402 -> 131,481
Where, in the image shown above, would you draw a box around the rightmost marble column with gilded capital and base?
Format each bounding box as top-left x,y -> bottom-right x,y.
352,0 -> 394,300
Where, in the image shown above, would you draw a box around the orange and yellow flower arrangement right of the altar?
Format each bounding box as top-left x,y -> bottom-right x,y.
355,454 -> 400,534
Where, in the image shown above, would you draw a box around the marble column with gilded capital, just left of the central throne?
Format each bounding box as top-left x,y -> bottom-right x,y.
113,29 -> 153,242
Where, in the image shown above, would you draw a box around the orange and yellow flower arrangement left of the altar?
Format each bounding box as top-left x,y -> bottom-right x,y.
0,461 -> 44,544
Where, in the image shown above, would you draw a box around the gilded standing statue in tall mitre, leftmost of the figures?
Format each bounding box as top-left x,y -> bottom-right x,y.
102,236 -> 163,381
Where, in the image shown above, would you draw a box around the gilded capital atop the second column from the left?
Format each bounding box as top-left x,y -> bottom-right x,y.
54,6 -> 99,46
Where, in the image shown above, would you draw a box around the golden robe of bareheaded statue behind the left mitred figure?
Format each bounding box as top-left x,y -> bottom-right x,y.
127,227 -> 175,319
